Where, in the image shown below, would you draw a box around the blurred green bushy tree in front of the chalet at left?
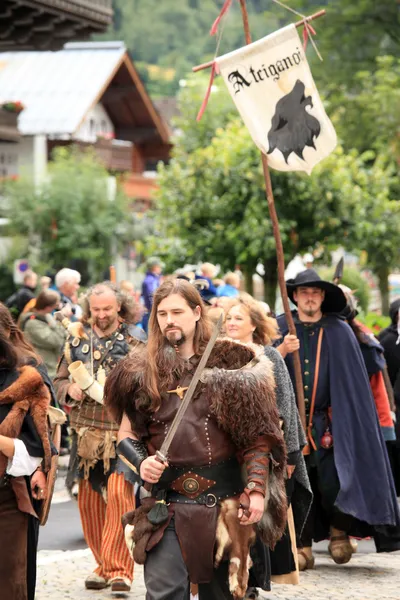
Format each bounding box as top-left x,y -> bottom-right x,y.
7,148 -> 128,281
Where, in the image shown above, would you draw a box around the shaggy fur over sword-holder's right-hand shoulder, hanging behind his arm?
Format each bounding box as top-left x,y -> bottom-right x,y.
201,340 -> 287,548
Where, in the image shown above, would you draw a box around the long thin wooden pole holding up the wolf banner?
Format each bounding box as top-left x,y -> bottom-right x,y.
240,0 -> 307,432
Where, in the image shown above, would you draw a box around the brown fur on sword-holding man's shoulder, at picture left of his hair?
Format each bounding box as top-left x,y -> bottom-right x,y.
104,343 -> 146,423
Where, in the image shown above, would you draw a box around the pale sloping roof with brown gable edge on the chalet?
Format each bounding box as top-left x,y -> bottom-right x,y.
0,42 -> 169,143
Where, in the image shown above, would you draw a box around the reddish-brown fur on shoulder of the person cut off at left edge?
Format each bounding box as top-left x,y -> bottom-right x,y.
0,366 -> 51,476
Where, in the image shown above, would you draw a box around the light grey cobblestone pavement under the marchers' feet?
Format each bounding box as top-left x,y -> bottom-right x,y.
36,550 -> 400,600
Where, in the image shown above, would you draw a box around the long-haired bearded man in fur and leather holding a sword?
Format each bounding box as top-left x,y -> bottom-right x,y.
105,279 -> 286,600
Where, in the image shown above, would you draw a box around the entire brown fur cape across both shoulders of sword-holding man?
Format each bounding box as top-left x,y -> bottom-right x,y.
105,339 -> 287,546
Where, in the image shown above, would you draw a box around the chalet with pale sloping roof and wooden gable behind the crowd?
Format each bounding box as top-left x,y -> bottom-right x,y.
0,42 -> 171,204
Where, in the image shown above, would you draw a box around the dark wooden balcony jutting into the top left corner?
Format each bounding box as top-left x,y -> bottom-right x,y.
0,0 -> 113,51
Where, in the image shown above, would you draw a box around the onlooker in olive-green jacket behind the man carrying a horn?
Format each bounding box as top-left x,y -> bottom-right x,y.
20,290 -> 67,379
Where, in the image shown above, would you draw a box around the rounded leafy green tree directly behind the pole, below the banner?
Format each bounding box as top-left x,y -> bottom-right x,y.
153,120 -> 359,305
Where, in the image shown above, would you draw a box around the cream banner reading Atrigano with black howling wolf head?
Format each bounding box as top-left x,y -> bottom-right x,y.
215,25 -> 337,174
